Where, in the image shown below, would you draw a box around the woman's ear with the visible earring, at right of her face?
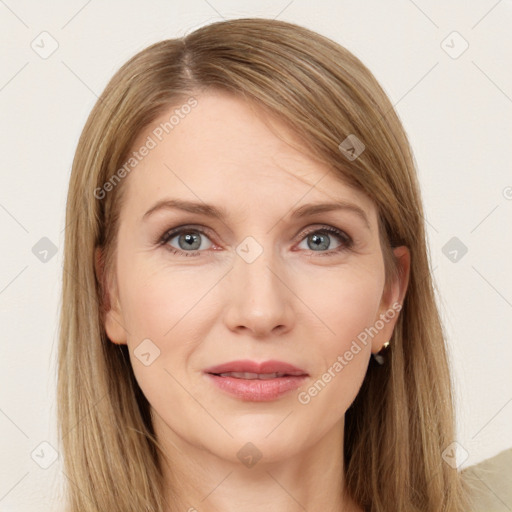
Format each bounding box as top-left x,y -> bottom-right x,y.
372,246 -> 411,354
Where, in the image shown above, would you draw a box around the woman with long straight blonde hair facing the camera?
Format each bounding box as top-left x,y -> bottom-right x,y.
58,19 -> 469,512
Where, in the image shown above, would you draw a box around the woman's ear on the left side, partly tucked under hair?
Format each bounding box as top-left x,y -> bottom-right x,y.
94,247 -> 126,345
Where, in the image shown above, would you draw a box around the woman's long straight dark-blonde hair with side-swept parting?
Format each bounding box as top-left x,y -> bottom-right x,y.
58,18 -> 468,512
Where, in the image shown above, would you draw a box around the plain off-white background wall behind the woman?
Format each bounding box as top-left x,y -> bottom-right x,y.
0,0 -> 512,512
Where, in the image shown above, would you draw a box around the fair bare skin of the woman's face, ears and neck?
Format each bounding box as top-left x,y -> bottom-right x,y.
100,92 -> 410,512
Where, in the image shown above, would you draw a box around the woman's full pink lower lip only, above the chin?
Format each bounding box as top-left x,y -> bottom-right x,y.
206,373 -> 307,402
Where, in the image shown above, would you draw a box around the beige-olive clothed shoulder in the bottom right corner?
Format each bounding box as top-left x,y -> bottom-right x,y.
461,448 -> 512,512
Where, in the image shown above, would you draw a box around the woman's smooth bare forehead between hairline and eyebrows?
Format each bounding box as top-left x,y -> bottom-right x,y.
120,91 -> 375,218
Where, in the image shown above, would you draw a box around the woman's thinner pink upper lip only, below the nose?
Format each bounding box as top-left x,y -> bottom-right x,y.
204,360 -> 308,379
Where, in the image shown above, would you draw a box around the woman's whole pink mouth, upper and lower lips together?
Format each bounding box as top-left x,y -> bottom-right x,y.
204,361 -> 309,402
